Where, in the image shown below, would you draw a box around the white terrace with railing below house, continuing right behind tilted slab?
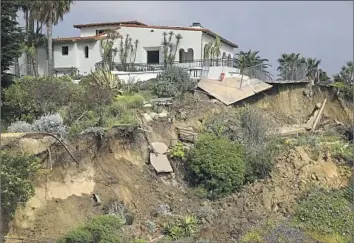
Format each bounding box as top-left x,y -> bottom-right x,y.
95,58 -> 308,83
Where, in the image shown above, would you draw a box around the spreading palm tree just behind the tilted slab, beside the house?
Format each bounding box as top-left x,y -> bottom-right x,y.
236,50 -> 271,81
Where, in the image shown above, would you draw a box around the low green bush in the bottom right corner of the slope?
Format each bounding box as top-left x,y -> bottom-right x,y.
294,189 -> 354,242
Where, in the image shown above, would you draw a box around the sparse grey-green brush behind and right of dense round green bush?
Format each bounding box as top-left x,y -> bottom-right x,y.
204,107 -> 281,182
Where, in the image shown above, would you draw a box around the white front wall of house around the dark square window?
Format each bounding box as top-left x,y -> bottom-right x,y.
115,27 -> 202,63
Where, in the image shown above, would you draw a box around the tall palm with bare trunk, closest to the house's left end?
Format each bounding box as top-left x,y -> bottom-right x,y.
34,0 -> 73,76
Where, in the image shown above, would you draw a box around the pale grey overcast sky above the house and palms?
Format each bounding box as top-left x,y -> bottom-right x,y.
18,1 -> 353,74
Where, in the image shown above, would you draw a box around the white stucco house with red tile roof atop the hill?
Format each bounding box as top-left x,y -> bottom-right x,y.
11,21 -> 238,79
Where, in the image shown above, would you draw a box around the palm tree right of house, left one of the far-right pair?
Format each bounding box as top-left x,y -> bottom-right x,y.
277,53 -> 306,80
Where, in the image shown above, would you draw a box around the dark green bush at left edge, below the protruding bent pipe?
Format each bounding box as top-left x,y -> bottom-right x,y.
0,150 -> 40,219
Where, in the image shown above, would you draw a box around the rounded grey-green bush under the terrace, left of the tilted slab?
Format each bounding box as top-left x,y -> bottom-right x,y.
153,66 -> 195,97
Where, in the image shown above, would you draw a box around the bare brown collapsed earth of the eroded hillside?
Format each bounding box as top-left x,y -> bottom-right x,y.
2,84 -> 353,242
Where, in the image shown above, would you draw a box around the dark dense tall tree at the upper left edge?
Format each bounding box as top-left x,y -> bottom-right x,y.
1,1 -> 23,87
